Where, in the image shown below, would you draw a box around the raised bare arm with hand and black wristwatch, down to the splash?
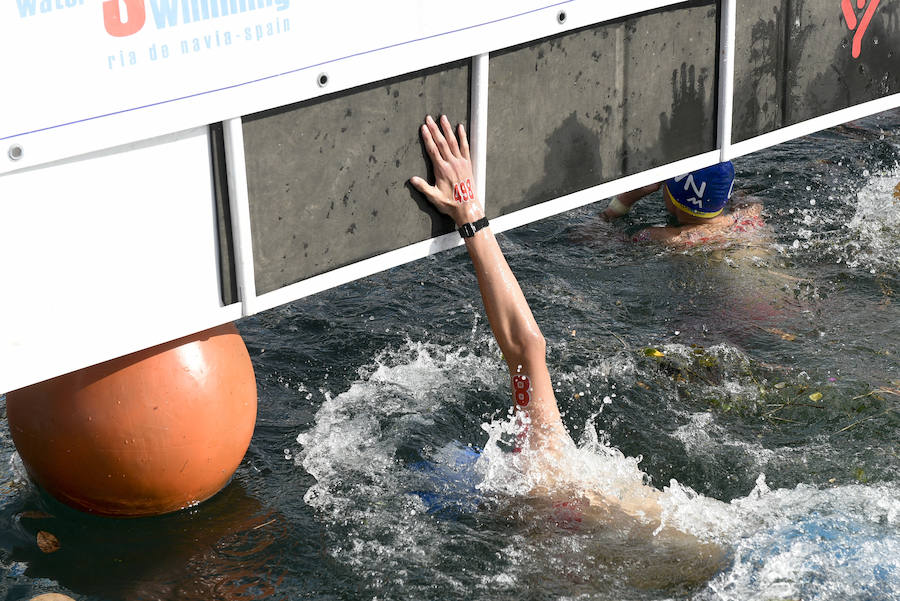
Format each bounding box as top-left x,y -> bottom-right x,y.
410,116 -> 562,441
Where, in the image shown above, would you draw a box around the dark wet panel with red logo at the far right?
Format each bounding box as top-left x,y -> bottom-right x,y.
733,0 -> 900,142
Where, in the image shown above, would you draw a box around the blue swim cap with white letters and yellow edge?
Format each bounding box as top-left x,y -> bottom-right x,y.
663,161 -> 734,219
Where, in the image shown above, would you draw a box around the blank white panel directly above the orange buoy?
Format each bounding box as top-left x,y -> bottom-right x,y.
0,127 -> 241,393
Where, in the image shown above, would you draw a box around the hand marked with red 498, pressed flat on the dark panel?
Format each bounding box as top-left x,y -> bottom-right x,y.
409,115 -> 484,227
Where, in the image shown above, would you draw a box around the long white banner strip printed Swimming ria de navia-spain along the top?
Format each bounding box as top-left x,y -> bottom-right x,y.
0,0 -> 678,173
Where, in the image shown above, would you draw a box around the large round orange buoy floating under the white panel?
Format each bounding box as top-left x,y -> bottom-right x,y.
6,324 -> 256,517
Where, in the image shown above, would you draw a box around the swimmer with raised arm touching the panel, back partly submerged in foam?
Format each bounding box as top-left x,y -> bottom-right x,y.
410,116 -> 722,575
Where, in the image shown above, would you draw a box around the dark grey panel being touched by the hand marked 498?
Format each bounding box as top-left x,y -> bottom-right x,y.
244,62 -> 469,294
